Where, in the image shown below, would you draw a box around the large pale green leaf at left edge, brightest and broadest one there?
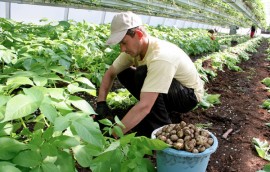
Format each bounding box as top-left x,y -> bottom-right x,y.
1,94 -> 40,122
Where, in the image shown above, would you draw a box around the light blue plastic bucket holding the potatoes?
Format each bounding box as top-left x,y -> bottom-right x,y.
151,127 -> 218,172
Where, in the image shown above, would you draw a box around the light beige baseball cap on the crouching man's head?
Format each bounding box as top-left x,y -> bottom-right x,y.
106,11 -> 143,45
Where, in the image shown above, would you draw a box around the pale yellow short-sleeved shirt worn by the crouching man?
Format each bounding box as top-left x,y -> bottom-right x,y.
113,37 -> 204,101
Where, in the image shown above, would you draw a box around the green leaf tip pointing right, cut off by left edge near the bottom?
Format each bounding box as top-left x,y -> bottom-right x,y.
0,137 -> 27,160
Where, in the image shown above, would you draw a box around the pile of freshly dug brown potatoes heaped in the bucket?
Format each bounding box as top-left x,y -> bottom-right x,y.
155,121 -> 214,153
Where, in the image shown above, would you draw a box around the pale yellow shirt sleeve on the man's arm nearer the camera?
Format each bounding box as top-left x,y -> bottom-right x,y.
141,60 -> 176,94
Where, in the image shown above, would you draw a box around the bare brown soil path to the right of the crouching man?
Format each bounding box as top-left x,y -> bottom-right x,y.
181,37 -> 270,172
